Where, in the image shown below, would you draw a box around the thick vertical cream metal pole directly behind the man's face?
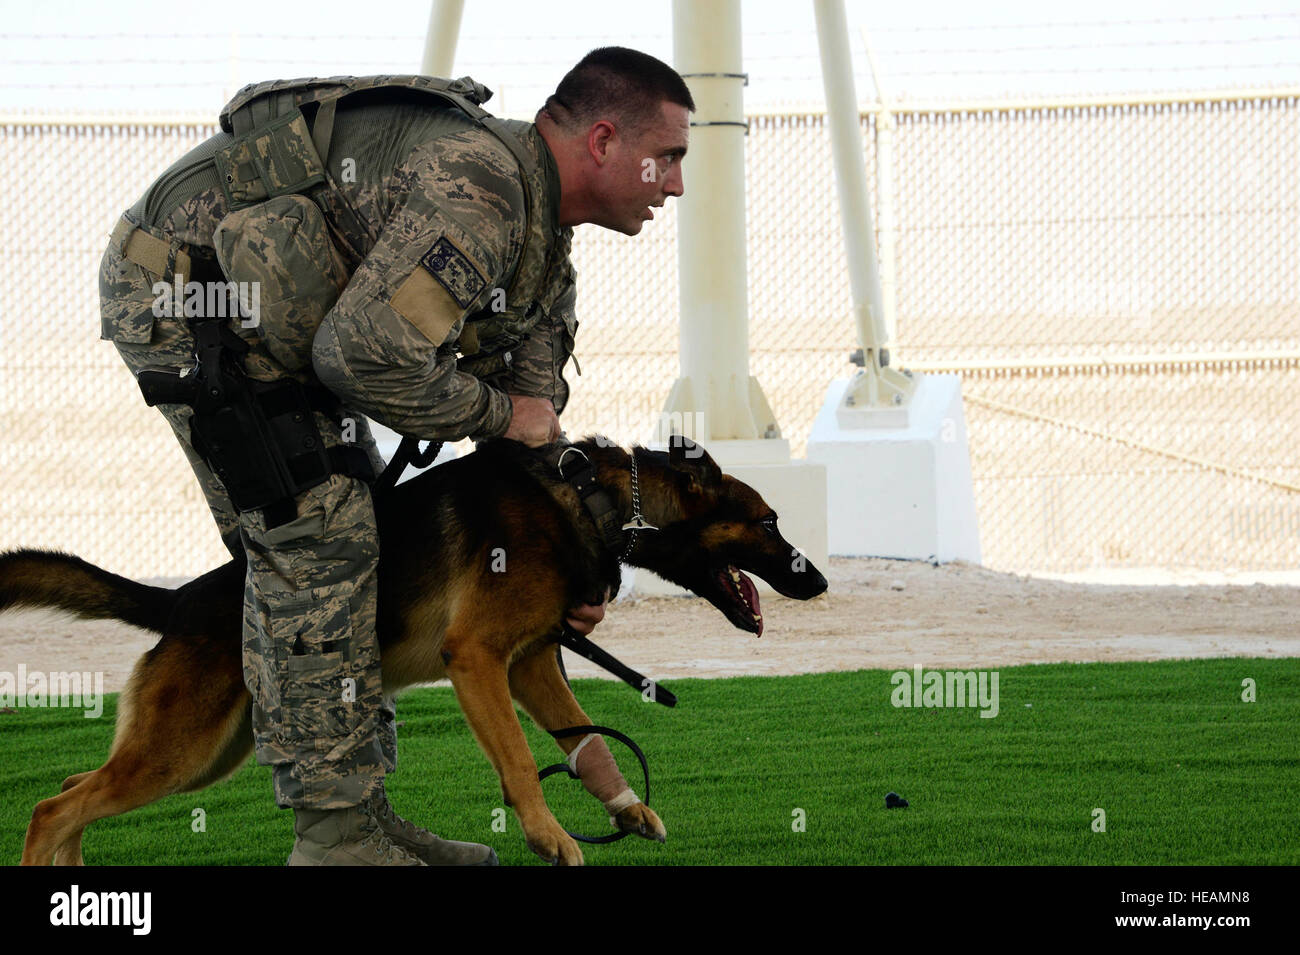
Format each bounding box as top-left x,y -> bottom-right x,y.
668,0 -> 762,440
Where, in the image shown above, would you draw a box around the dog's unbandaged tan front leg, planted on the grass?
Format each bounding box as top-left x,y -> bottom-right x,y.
443,638 -> 582,865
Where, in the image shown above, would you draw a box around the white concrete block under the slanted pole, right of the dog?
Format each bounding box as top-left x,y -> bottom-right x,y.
807,374 -> 980,564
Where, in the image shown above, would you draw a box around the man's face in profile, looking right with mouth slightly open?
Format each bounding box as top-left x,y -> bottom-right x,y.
593,100 -> 690,235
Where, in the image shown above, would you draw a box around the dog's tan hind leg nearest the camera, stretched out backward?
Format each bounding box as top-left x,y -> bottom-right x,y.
22,639 -> 252,865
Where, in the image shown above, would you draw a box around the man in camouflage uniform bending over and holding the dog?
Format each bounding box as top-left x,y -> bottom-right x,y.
100,47 -> 694,865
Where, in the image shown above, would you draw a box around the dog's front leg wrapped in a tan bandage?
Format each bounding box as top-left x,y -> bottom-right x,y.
510,643 -> 668,842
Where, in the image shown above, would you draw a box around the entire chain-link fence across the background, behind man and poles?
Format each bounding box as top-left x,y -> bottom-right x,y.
0,91 -> 1300,577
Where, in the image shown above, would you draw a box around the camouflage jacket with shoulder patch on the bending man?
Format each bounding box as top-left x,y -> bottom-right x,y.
133,81 -> 577,439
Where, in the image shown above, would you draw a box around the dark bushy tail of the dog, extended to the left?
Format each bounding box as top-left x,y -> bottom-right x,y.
0,551 -> 177,633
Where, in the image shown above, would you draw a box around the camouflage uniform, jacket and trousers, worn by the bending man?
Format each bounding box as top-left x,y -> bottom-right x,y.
100,81 -> 576,809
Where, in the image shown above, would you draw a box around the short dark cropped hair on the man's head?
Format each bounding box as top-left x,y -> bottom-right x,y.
538,47 -> 696,134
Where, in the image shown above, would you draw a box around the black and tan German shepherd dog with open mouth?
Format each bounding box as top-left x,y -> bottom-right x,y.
0,438 -> 827,865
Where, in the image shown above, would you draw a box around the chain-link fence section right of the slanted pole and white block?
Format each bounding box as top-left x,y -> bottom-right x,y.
891,96 -> 1300,572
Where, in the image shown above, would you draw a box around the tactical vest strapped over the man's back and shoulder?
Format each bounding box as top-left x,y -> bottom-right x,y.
215,75 -> 572,366
